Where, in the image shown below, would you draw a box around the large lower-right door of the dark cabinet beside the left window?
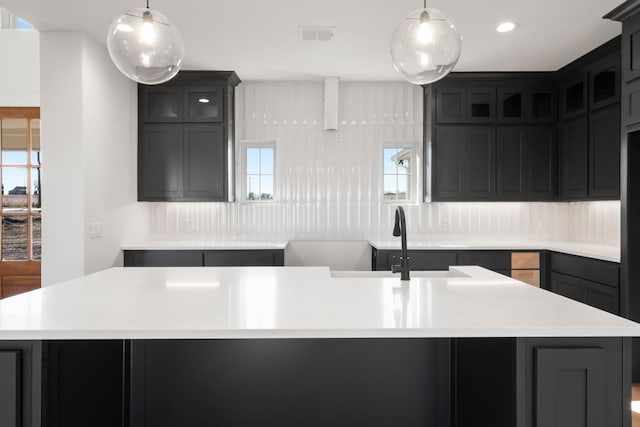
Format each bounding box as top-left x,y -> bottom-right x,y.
183,125 -> 227,201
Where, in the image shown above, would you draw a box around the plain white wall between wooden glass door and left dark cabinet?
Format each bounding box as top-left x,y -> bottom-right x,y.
41,32 -> 148,285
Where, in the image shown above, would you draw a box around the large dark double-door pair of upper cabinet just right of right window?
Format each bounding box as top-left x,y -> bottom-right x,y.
433,126 -> 496,201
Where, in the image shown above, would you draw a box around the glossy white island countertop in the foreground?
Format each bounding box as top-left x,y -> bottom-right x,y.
0,267 -> 640,340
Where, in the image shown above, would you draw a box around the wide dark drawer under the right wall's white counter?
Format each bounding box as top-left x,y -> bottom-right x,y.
551,252 -> 620,288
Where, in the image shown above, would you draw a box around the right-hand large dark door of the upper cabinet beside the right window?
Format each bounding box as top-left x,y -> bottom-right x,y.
462,127 -> 496,201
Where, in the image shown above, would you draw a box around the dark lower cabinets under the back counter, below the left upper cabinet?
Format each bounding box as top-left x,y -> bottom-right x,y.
124,249 -> 284,267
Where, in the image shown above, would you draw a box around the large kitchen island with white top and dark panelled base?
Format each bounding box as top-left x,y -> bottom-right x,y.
0,267 -> 640,427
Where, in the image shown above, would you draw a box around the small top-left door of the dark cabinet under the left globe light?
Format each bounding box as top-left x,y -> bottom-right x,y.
139,85 -> 183,123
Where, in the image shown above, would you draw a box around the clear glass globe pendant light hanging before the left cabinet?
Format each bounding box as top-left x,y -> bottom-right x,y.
107,0 -> 184,85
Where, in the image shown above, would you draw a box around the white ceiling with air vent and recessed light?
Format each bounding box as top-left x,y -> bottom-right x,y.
0,0 -> 622,80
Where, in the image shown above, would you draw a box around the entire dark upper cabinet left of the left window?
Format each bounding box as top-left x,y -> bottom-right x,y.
138,71 -> 240,202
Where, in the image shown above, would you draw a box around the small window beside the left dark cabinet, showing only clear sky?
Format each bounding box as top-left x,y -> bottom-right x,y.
240,141 -> 276,202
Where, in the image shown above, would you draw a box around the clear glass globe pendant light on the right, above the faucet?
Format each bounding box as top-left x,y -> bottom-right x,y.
391,0 -> 462,85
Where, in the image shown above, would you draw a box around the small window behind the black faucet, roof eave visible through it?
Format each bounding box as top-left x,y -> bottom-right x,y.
382,143 -> 416,202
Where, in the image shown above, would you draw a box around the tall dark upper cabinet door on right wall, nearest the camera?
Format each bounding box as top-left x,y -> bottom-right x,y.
589,105 -> 620,199
